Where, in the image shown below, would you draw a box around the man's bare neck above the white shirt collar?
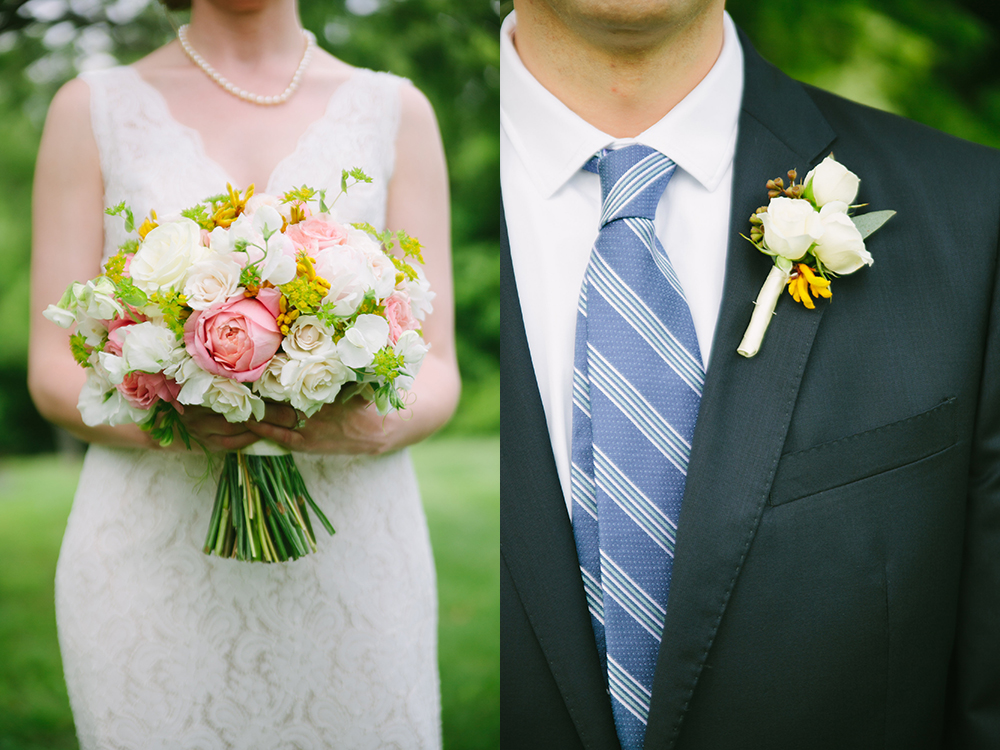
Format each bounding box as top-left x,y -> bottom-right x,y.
514,0 -> 725,138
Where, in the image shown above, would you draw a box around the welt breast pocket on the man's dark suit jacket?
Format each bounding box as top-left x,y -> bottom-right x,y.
768,398 -> 956,505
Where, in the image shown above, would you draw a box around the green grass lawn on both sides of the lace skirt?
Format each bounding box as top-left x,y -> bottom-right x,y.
0,437 -> 500,750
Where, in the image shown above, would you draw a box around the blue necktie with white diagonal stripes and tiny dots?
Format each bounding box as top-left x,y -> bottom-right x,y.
572,144 -> 705,750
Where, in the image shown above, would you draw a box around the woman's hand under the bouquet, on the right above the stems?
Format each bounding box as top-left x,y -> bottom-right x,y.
247,397 -> 401,455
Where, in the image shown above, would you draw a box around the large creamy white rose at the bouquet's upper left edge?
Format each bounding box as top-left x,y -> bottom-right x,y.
129,219 -> 208,294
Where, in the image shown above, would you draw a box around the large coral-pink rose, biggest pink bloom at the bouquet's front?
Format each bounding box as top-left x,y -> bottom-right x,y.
184,288 -> 282,382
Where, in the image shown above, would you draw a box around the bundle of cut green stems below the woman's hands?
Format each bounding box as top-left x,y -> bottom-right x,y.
205,451 -> 334,562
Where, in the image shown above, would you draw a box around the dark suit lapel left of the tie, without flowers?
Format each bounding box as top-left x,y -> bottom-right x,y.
500,209 -> 619,750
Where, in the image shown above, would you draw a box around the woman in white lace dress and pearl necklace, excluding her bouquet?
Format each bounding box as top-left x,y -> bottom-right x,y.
29,0 -> 459,750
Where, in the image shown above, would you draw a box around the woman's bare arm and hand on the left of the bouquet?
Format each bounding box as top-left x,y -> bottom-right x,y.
28,79 -> 257,450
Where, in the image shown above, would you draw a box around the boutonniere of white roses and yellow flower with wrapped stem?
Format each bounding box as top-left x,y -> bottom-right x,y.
736,154 -> 896,357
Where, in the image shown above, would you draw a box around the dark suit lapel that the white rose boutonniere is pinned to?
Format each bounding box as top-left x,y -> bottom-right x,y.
645,36 -> 834,750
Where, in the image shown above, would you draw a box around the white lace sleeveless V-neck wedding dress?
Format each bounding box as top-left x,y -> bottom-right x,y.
56,67 -> 441,750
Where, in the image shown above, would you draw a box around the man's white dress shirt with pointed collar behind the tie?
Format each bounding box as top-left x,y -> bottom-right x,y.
500,13 -> 749,516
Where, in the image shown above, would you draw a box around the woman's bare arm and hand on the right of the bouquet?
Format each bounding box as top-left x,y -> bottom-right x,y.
251,86 -> 460,453
